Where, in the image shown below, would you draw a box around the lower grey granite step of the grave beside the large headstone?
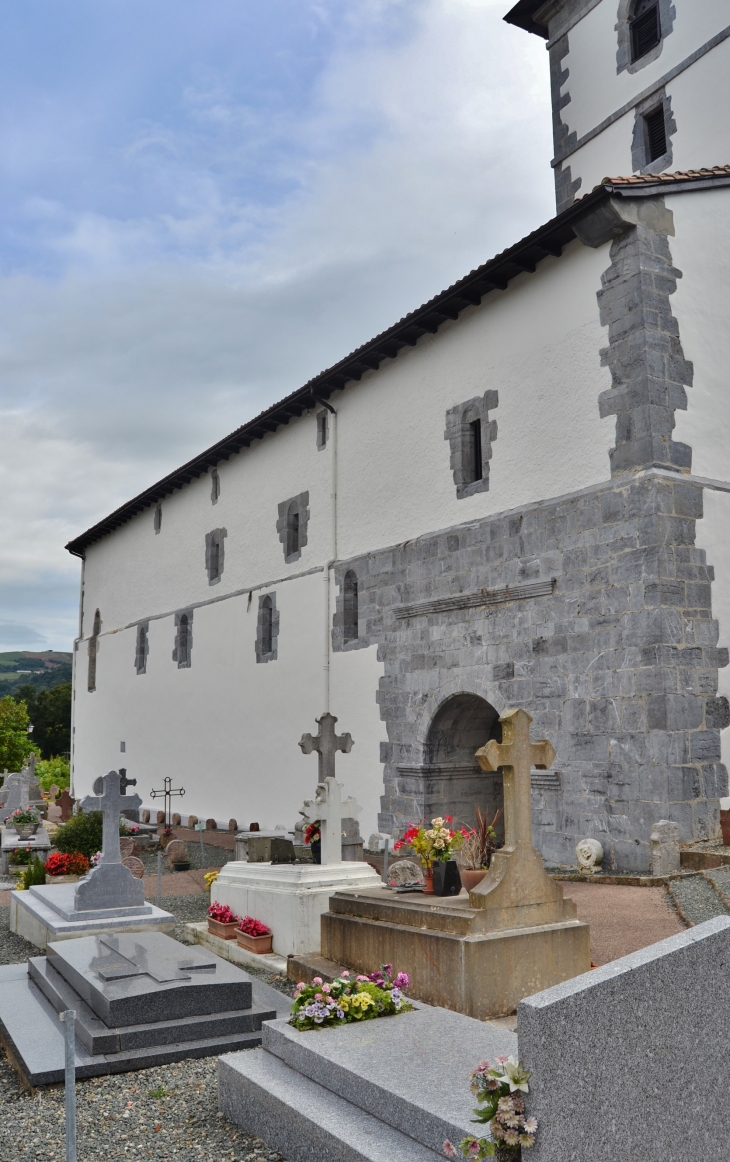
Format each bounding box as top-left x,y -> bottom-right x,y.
217,1045 -> 444,1162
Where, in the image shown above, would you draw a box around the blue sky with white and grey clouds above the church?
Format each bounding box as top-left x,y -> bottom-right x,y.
0,0 -> 554,651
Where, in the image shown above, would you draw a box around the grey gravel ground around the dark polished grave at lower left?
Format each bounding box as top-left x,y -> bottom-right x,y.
0,892 -> 293,1162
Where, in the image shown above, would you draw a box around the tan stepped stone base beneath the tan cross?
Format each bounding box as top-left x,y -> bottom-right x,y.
321,889 -> 591,1020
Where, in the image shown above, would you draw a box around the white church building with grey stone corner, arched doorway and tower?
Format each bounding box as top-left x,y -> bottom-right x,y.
67,0 -> 730,869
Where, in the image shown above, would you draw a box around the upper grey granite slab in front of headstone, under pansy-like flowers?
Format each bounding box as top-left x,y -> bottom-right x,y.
262,1005 -> 517,1153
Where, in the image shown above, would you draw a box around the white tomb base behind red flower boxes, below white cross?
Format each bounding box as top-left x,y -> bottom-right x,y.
212,862 -> 380,956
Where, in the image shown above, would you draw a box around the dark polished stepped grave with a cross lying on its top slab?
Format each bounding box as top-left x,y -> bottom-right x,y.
0,932 -> 282,1082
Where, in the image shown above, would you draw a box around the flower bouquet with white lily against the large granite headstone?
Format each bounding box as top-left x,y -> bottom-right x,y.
444,1057 -> 537,1162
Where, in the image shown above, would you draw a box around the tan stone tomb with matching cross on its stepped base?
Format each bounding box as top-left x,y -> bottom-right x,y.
320,710 -> 591,1019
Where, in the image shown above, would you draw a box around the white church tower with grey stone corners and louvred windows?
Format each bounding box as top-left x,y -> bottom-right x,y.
504,0 -> 730,210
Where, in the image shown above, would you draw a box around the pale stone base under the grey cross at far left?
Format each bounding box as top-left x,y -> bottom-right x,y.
10,883 -> 174,948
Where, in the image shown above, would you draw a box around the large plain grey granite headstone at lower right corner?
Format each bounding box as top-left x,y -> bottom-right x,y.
517,916 -> 730,1162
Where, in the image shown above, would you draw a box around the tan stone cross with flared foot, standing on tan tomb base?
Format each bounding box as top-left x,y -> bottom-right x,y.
470,710 -> 567,931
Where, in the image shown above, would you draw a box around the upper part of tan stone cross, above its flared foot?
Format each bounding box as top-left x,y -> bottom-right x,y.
477,710 -> 556,848
